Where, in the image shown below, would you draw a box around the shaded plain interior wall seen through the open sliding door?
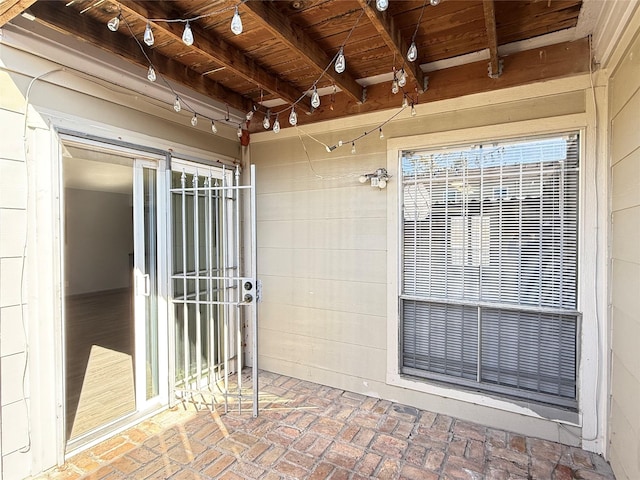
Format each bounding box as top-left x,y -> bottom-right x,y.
65,188 -> 133,295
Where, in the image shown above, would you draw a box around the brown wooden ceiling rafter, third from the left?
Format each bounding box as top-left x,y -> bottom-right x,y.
240,2 -> 364,102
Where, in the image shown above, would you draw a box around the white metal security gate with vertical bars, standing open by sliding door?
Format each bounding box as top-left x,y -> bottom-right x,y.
170,160 -> 258,416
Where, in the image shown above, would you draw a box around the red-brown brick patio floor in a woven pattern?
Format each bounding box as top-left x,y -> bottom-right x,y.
40,372 -> 614,480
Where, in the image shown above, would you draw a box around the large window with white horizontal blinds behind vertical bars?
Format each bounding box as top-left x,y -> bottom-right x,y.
400,134 -> 579,409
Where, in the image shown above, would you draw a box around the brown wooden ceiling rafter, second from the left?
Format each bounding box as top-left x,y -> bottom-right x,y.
119,1 -> 308,111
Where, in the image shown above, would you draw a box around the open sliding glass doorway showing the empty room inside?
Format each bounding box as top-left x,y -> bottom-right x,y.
62,139 -> 167,452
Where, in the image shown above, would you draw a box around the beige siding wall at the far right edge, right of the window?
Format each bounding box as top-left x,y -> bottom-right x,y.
609,20 -> 640,479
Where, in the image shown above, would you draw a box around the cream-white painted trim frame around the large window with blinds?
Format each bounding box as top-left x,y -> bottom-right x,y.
386,114 -> 607,450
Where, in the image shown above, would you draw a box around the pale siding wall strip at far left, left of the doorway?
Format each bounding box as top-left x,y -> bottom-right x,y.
0,72 -> 29,478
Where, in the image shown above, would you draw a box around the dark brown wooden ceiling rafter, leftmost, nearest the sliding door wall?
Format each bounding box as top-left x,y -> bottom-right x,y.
31,2 -> 252,112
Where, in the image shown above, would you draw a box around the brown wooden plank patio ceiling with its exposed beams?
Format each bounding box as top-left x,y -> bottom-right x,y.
0,0 -> 589,131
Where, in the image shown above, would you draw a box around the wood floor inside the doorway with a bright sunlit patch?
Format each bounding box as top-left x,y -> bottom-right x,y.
65,289 -> 136,440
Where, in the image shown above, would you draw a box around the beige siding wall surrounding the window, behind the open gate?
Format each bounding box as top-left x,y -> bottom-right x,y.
251,88 -> 585,442
